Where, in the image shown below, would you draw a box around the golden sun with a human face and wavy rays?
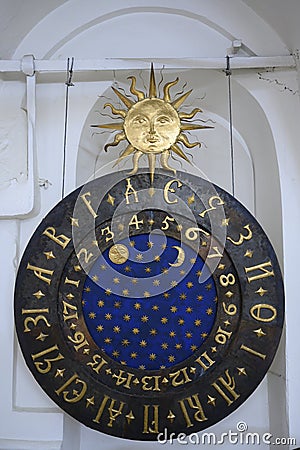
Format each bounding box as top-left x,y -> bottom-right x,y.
91,64 -> 213,183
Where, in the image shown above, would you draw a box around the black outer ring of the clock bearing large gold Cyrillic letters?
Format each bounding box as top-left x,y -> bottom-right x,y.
15,172 -> 284,440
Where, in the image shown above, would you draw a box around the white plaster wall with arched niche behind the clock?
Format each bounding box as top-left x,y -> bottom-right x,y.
0,0 -> 300,450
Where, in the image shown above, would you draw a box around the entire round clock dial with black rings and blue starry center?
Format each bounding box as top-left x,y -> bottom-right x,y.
15,172 -> 284,440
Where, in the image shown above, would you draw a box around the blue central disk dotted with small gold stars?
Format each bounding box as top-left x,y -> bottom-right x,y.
82,233 -> 217,370
